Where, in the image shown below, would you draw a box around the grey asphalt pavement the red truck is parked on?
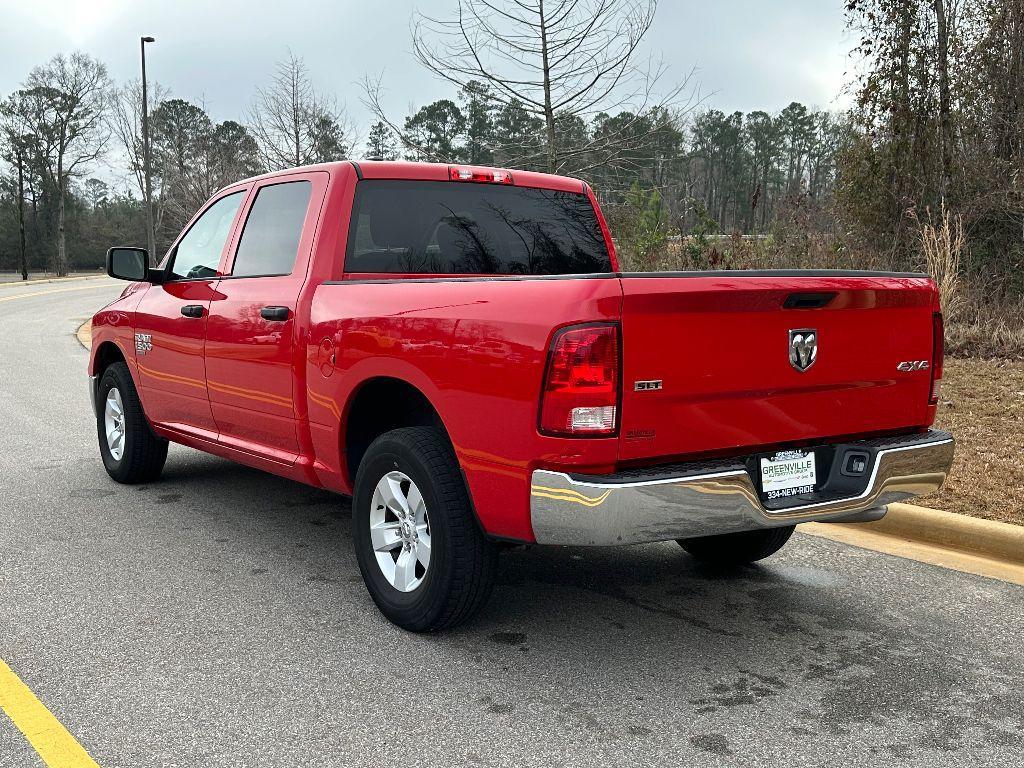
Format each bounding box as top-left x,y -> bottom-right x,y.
0,281 -> 1024,768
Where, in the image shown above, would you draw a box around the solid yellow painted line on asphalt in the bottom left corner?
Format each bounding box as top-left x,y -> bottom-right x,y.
0,659 -> 99,768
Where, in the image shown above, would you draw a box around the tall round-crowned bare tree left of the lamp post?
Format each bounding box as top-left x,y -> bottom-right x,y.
19,52 -> 111,275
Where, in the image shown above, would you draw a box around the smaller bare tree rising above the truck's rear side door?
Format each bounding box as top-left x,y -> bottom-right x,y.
247,51 -> 351,170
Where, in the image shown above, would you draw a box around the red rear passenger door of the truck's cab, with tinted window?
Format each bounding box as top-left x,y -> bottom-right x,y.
205,172 -> 328,463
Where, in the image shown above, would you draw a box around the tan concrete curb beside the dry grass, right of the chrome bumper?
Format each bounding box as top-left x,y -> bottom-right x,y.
799,504 -> 1024,585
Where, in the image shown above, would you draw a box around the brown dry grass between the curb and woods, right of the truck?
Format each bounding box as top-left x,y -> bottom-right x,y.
921,358 -> 1024,525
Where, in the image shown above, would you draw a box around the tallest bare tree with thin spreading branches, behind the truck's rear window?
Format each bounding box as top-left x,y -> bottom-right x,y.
395,0 -> 689,173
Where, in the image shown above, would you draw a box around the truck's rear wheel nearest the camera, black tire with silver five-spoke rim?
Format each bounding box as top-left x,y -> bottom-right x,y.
352,427 -> 498,632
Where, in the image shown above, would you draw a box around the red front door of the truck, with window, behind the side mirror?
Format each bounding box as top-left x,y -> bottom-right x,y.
135,189 -> 248,439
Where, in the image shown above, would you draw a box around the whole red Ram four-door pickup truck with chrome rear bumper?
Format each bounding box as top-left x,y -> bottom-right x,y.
89,162 -> 953,631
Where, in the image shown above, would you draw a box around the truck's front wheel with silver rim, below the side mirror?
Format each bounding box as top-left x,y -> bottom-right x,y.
96,362 -> 167,485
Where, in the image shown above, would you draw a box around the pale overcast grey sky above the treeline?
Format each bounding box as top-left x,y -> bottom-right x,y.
0,0 -> 851,145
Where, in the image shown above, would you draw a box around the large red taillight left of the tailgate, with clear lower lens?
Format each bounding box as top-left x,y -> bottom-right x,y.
540,323 -> 620,436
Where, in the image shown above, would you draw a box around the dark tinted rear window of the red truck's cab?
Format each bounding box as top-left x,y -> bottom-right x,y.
345,179 -> 611,274
